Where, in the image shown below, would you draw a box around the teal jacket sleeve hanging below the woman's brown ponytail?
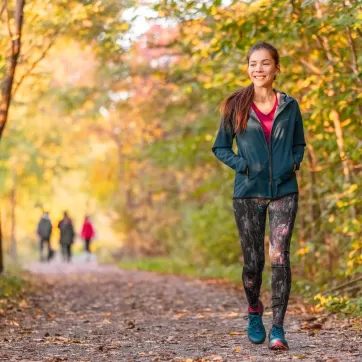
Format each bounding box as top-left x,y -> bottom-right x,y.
212,122 -> 247,173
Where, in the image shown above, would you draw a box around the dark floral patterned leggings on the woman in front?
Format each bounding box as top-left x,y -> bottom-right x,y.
233,194 -> 298,325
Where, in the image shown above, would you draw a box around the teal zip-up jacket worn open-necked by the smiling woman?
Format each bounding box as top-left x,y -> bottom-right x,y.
212,92 -> 306,199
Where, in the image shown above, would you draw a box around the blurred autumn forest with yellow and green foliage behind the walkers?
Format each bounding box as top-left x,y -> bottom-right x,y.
0,0 -> 362,313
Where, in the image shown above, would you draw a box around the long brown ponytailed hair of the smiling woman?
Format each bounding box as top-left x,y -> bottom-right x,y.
219,42 -> 279,133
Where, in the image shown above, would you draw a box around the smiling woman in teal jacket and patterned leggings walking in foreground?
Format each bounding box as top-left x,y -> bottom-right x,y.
212,42 -> 306,350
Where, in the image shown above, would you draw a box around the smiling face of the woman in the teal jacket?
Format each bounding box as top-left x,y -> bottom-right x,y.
248,49 -> 280,88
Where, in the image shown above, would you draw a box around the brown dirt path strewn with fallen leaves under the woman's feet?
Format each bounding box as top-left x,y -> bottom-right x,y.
0,261 -> 362,362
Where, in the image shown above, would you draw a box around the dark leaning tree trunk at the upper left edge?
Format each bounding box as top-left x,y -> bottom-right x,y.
0,0 -> 25,139
